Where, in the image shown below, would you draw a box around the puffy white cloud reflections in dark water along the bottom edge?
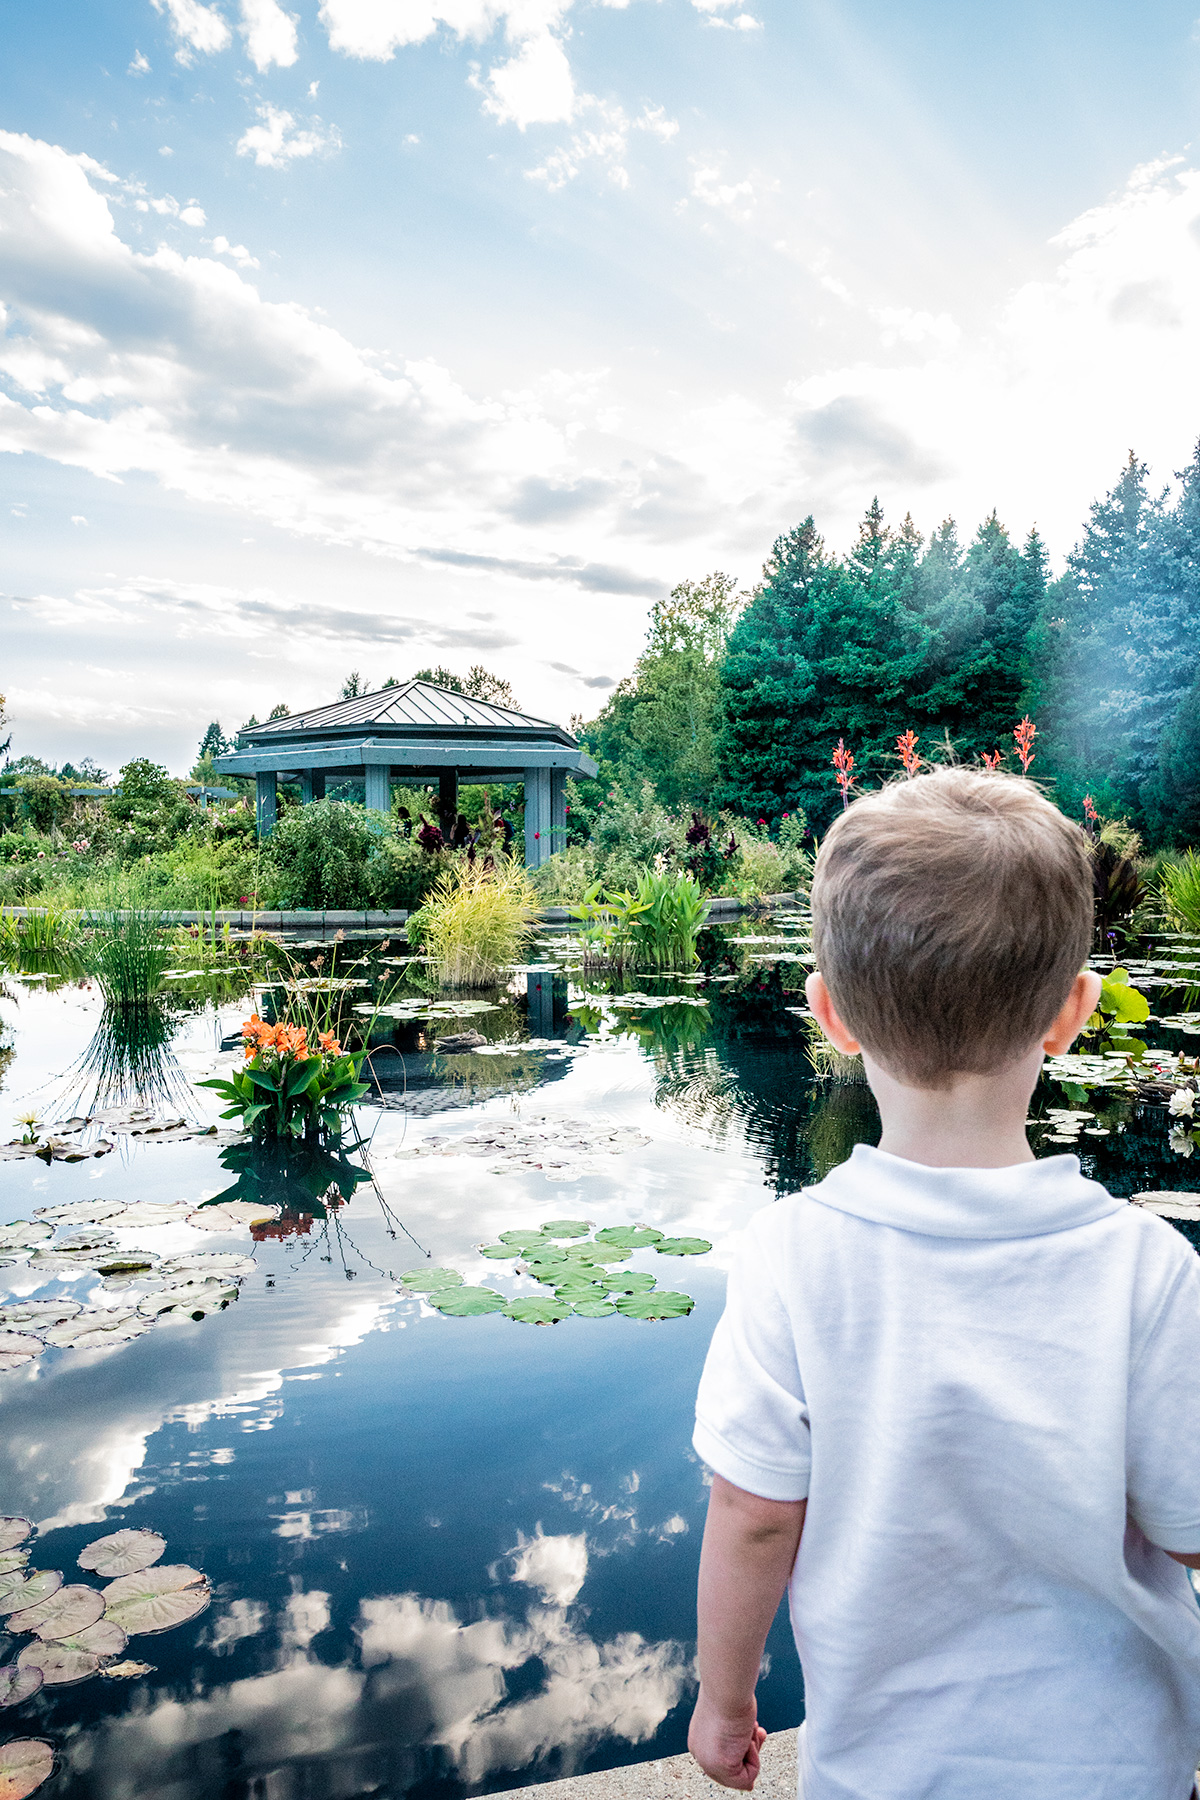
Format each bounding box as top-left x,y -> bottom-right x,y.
75,1584 -> 693,1800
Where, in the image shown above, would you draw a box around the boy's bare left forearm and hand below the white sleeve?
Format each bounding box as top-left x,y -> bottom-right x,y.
687,1474 -> 808,1789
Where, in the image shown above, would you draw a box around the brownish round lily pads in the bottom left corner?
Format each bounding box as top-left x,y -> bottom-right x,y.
0,1517 -> 212,1800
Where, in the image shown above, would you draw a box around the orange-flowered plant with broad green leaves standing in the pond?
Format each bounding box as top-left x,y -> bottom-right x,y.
196,1013 -> 369,1138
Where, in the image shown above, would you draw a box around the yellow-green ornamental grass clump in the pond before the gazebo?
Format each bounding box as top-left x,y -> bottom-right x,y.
421,860 -> 538,988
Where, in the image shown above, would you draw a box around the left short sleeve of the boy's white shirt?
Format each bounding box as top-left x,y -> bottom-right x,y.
693,1222 -> 811,1499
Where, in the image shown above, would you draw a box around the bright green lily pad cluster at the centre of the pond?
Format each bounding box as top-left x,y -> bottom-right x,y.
401,1219 -> 712,1325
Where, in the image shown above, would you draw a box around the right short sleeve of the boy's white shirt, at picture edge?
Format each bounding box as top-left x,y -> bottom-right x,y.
1126,1255 -> 1200,1555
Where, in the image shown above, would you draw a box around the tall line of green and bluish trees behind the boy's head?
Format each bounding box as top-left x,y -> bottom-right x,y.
581,450 -> 1200,844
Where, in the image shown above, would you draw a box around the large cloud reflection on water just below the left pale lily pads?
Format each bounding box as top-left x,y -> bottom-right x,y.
0,1282 -> 390,1532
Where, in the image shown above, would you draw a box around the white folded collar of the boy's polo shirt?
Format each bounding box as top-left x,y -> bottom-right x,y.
804,1143 -> 1128,1238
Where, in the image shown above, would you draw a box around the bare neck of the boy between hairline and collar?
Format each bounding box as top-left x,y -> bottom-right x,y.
862,1046 -> 1042,1168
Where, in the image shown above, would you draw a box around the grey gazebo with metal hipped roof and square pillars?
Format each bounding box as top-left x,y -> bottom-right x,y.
212,680 -> 596,869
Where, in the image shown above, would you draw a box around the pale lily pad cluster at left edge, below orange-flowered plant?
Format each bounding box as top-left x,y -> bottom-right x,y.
0,1201 -> 263,1368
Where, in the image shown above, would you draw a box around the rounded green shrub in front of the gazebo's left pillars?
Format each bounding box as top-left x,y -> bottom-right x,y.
263,799 -> 387,911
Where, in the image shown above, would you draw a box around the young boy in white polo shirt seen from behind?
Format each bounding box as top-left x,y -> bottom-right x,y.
689,769 -> 1200,1800
